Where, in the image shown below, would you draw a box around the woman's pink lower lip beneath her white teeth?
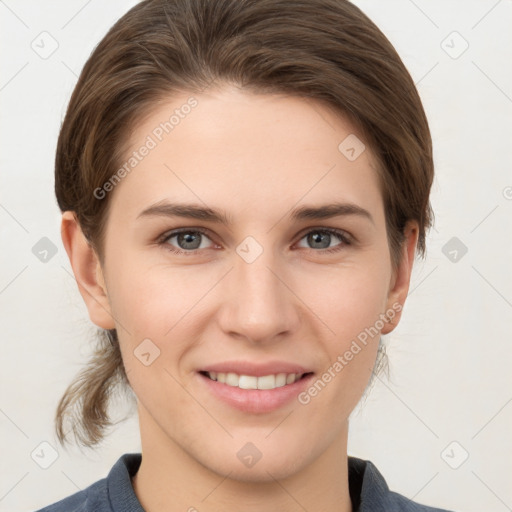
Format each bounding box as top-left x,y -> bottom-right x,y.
198,373 -> 314,413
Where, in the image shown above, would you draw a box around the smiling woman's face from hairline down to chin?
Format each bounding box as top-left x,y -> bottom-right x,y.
71,87 -> 415,481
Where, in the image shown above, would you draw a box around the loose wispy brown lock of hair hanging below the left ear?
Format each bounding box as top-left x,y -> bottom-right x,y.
55,329 -> 128,447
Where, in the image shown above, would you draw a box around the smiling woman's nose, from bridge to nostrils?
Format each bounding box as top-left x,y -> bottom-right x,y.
218,244 -> 301,343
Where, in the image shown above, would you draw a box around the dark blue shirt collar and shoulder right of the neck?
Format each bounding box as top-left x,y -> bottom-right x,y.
348,457 -> 456,512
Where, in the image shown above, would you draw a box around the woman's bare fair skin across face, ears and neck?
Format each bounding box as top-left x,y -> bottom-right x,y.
62,86 -> 418,512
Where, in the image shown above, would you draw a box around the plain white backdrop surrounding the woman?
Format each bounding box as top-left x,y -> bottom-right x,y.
0,0 -> 512,512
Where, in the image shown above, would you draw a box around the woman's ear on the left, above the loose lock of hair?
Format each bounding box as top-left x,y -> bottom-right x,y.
61,211 -> 115,329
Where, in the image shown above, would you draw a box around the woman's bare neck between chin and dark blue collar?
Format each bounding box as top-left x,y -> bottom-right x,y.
132,411 -> 352,512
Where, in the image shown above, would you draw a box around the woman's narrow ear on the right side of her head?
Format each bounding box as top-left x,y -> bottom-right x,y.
381,221 -> 419,334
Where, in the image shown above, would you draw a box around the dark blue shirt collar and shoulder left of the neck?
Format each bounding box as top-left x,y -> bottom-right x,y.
36,453 -> 144,512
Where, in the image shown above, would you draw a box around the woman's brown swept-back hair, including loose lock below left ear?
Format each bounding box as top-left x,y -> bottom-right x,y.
55,0 -> 434,446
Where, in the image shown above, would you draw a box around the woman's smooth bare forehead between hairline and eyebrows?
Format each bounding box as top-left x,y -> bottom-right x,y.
110,87 -> 382,224
